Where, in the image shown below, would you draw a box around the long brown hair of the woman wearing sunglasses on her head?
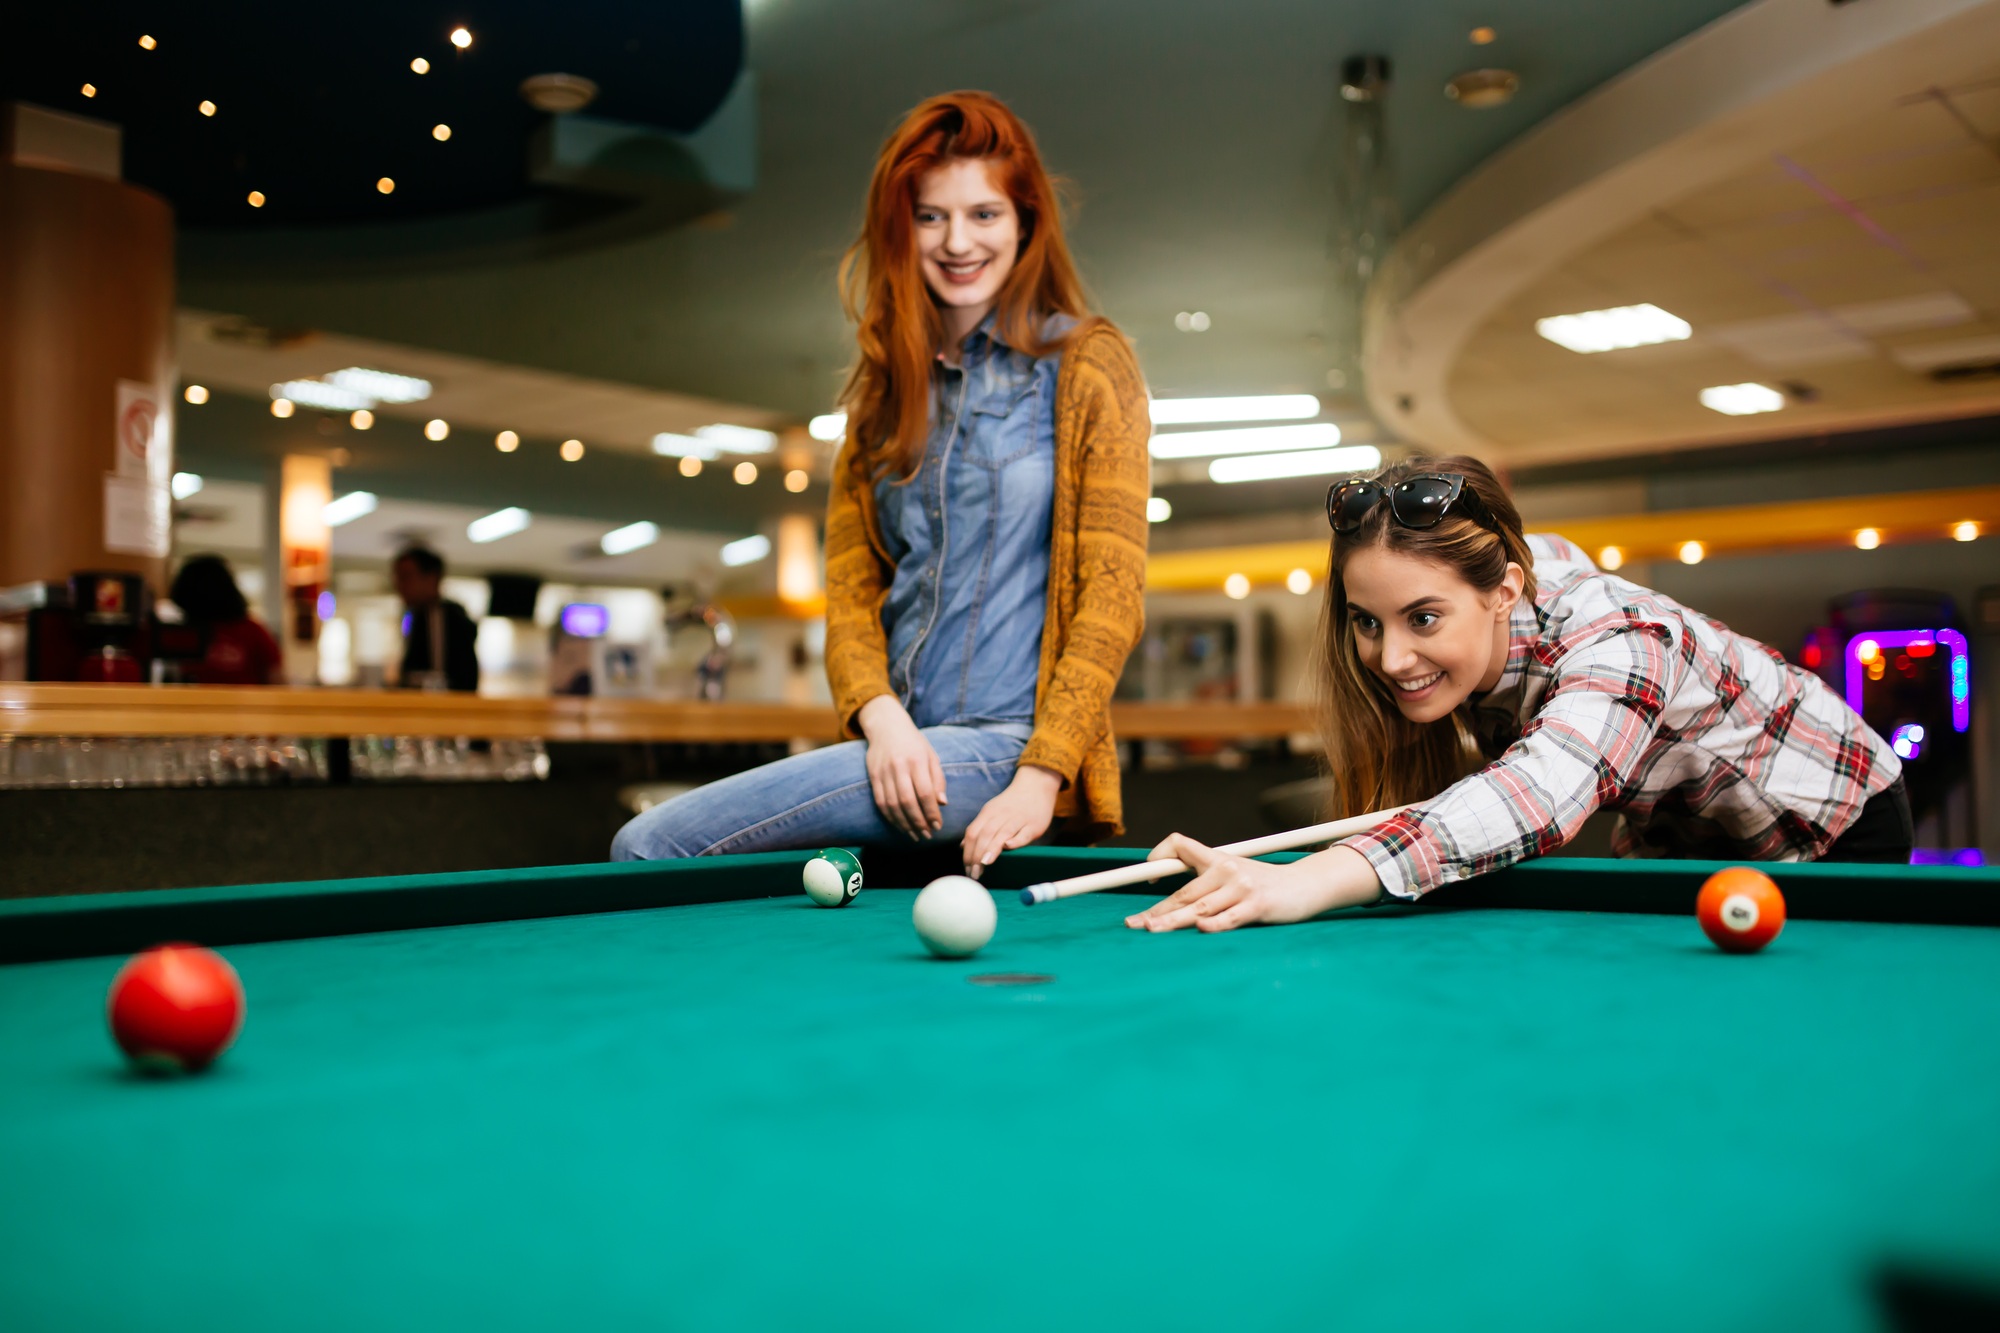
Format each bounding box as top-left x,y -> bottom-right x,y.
1314,456 -> 1534,819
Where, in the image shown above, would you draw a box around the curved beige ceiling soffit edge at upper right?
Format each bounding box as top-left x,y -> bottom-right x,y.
1362,0 -> 2000,454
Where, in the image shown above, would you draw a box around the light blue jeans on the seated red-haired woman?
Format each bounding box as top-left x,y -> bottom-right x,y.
612,727 -> 1030,861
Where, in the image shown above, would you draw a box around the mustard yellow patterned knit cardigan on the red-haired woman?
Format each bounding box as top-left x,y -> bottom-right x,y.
826,322 -> 1152,841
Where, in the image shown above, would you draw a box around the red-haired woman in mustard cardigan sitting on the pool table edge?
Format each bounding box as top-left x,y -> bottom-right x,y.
612,92 -> 1150,875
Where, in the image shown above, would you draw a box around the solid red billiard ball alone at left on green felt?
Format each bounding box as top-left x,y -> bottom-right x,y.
106,932 -> 244,1073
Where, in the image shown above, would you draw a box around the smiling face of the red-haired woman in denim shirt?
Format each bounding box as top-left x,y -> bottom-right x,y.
916,158 -> 1022,346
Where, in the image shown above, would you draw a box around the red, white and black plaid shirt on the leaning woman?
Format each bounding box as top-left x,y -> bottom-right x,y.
1346,534 -> 1902,899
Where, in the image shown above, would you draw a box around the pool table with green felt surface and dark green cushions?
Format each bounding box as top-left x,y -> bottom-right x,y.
0,849 -> 2000,1333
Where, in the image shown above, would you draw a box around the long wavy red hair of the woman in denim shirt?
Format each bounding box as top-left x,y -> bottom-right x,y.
840,92 -> 1090,478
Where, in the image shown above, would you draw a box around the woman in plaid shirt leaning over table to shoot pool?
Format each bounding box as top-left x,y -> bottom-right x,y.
1126,458 -> 1912,931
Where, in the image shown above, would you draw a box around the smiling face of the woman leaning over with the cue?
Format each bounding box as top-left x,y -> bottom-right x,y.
1340,546 -> 1524,723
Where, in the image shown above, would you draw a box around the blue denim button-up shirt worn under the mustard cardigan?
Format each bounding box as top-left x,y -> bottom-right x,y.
876,316 -> 1068,739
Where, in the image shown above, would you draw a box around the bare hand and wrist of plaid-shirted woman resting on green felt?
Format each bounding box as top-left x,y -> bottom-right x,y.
1126,833 -> 1382,931
